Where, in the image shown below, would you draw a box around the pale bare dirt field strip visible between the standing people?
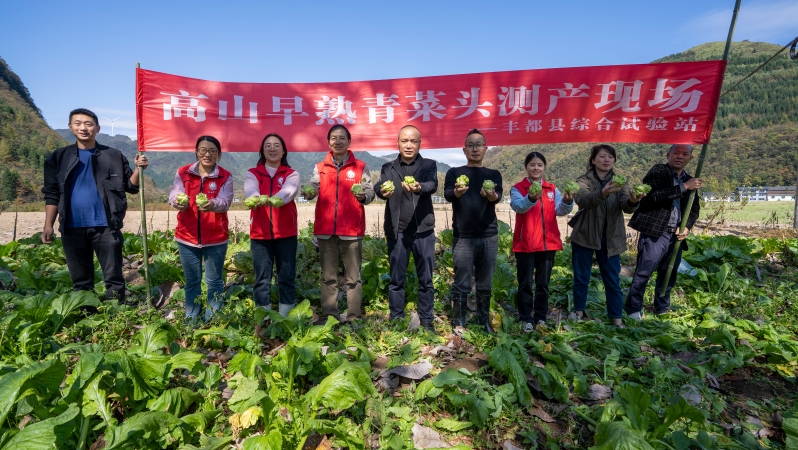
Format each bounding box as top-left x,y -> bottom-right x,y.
0,203 -> 584,244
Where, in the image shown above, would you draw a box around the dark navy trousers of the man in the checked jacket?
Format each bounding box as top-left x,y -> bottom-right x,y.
624,231 -> 682,314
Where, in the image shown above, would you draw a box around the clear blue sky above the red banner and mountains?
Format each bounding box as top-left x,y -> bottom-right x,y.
0,0 -> 798,164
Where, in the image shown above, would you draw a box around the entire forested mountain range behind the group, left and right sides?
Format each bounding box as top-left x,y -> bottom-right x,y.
0,41 -> 798,202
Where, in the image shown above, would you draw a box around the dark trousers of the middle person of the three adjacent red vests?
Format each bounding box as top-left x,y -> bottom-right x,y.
250,236 -> 297,308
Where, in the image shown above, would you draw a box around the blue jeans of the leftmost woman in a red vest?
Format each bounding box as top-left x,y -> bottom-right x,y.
177,242 -> 227,322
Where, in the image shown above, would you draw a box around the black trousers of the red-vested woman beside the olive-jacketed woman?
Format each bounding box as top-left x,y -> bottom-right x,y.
515,250 -> 556,323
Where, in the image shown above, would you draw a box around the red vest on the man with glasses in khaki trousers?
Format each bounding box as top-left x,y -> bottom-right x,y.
313,151 -> 366,236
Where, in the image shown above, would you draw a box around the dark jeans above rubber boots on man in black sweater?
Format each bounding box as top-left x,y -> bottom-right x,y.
452,235 -> 499,294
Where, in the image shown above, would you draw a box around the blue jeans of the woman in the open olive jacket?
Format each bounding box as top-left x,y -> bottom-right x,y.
571,239 -> 623,319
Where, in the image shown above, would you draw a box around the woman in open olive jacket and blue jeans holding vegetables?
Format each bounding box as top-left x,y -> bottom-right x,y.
568,144 -> 645,327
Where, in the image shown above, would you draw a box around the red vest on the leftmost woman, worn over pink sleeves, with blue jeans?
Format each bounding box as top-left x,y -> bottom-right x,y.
175,163 -> 230,245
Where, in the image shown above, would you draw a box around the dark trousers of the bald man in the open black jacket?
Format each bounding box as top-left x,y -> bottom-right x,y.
388,230 -> 435,321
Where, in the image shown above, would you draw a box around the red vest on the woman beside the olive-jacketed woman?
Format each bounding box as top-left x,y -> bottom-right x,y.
513,178 -> 562,253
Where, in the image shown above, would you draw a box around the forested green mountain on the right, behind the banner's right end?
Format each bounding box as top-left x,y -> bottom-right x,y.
485,41 -> 798,186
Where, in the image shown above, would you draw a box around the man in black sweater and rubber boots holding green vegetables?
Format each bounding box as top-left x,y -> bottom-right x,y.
443,129 -> 503,333
